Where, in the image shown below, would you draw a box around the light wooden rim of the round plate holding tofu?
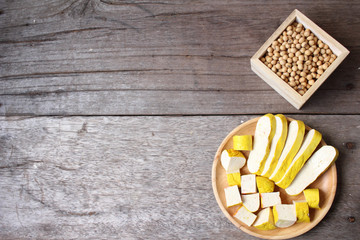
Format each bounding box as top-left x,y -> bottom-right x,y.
212,117 -> 337,239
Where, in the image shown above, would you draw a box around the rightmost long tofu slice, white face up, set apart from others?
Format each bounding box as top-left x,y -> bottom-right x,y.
285,145 -> 339,195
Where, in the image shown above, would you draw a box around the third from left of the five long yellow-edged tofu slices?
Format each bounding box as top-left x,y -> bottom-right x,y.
270,120 -> 305,182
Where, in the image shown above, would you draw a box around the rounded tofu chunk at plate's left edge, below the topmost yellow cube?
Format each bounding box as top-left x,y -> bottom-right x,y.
220,149 -> 246,173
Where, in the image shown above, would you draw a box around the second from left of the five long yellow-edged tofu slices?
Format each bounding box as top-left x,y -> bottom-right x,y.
261,114 -> 288,177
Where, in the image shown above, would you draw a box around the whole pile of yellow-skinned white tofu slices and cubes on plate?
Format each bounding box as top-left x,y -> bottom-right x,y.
221,114 -> 338,230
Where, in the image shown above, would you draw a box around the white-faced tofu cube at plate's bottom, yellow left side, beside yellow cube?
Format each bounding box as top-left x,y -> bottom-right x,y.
273,204 -> 296,228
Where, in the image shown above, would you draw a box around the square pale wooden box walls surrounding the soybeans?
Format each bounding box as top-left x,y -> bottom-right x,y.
250,9 -> 349,109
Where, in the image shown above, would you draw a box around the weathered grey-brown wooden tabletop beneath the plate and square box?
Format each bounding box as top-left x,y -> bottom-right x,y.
0,0 -> 360,239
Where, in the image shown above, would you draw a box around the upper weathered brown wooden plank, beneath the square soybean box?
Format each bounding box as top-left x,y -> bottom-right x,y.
0,0 -> 360,116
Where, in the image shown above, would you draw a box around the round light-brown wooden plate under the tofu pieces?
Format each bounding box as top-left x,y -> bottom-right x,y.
212,118 -> 337,239
